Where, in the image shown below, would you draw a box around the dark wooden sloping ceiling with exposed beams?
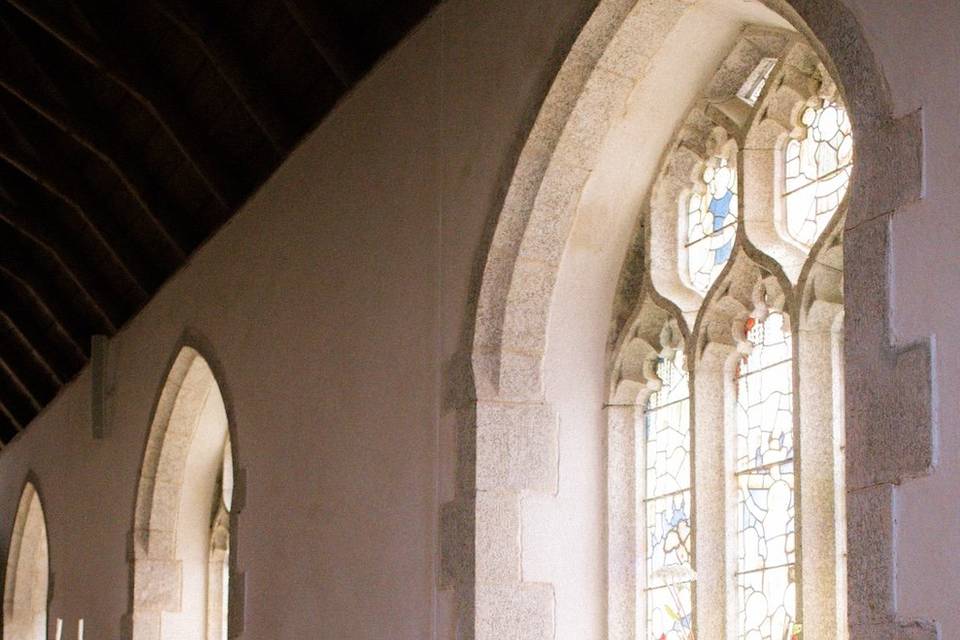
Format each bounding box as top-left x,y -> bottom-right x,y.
0,0 -> 437,444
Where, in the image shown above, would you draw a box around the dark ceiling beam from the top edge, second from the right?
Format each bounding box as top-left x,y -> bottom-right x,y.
153,0 -> 297,152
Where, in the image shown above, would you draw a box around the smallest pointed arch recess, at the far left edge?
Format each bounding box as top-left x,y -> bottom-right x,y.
3,482 -> 50,640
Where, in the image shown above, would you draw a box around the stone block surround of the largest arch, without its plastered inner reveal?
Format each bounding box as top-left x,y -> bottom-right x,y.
464,0 -> 936,639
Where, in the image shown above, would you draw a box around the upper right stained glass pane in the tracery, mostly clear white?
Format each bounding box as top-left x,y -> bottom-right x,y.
784,100 -> 853,246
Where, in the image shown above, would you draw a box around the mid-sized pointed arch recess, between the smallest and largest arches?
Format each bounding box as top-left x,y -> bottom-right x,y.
130,347 -> 234,640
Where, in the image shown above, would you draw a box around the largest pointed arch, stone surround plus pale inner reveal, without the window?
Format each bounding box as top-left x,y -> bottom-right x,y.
461,0 -> 936,640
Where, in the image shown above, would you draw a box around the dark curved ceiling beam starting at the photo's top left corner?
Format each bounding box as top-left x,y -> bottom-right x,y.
6,0 -> 245,211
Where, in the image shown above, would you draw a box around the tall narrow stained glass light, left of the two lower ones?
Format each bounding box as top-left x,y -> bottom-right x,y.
643,350 -> 693,640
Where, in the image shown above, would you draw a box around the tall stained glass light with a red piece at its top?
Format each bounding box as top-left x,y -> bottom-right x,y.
735,312 -> 799,640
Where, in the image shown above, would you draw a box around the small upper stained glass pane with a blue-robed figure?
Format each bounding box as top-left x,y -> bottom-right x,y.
686,158 -> 737,293
